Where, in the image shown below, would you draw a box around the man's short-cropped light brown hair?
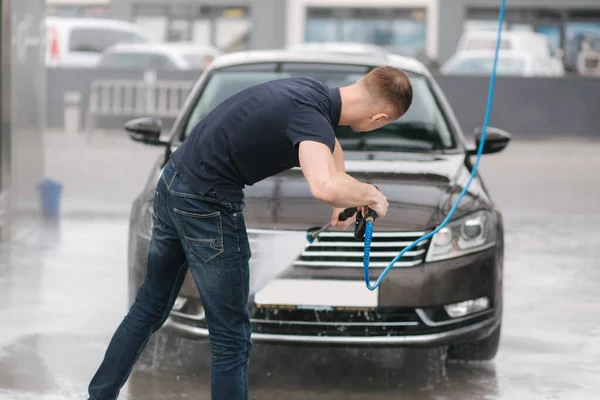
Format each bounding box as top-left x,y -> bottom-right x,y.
360,66 -> 413,119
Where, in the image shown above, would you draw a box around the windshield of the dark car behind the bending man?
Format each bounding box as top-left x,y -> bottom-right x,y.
183,66 -> 456,157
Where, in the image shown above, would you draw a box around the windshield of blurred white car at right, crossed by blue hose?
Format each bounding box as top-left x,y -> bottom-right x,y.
445,56 -> 525,75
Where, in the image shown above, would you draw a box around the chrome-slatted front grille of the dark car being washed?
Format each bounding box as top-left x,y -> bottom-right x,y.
294,232 -> 429,268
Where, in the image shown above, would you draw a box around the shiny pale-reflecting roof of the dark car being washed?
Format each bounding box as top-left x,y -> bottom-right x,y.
211,49 -> 430,75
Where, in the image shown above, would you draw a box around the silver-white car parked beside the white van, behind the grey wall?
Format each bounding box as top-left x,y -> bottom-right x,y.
98,43 -> 220,71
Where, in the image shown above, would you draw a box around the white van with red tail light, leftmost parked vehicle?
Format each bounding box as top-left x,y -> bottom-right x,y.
46,17 -> 149,68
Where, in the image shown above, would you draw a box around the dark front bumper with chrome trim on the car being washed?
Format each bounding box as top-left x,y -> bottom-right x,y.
130,219 -> 502,347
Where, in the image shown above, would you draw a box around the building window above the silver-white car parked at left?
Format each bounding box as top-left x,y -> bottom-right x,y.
134,3 -> 252,51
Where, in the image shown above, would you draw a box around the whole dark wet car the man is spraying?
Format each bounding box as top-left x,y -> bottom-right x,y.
126,50 -> 510,360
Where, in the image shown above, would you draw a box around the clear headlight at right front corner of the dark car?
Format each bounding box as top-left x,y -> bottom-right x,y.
426,211 -> 496,261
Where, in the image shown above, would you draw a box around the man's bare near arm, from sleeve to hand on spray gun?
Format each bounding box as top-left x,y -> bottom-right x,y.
298,140 -> 380,209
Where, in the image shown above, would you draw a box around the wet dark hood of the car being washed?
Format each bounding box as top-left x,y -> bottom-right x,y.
244,154 -> 490,232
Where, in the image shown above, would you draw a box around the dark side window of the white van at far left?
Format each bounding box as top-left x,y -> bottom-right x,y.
69,28 -> 147,53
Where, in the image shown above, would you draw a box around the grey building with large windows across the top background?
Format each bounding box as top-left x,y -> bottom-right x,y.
43,0 -> 600,68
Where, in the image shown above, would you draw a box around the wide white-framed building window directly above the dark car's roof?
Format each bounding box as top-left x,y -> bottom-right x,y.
304,7 -> 427,56
